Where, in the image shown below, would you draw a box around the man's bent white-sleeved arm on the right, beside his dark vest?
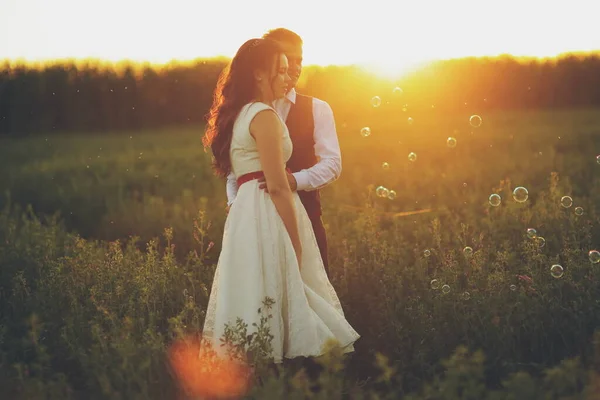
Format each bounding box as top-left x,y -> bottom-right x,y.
293,98 -> 342,191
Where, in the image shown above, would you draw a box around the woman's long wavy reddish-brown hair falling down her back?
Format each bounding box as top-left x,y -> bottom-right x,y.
202,39 -> 283,177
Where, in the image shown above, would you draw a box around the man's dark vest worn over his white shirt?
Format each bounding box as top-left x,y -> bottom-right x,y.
285,93 -> 321,218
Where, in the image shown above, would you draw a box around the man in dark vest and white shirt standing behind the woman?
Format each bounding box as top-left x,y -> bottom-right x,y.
227,28 -> 342,276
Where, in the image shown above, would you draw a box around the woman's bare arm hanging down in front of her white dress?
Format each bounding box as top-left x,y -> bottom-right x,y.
250,110 -> 302,265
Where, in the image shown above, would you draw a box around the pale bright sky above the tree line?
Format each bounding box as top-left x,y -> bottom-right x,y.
0,0 -> 600,76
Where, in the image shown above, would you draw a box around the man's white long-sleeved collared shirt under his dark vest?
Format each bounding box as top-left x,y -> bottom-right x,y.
227,89 -> 342,206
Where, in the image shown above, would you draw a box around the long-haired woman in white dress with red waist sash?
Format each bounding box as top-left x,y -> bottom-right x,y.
203,39 -> 360,363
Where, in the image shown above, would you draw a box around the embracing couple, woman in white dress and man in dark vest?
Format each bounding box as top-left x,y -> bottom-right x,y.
203,28 -> 359,363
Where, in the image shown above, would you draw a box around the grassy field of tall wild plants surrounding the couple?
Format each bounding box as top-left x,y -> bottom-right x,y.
0,109 -> 600,399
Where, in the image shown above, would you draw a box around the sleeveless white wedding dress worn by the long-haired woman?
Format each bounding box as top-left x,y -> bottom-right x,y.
203,102 -> 360,363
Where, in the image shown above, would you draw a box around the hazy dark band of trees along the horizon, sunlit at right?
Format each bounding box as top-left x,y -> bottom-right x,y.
0,54 -> 600,134
